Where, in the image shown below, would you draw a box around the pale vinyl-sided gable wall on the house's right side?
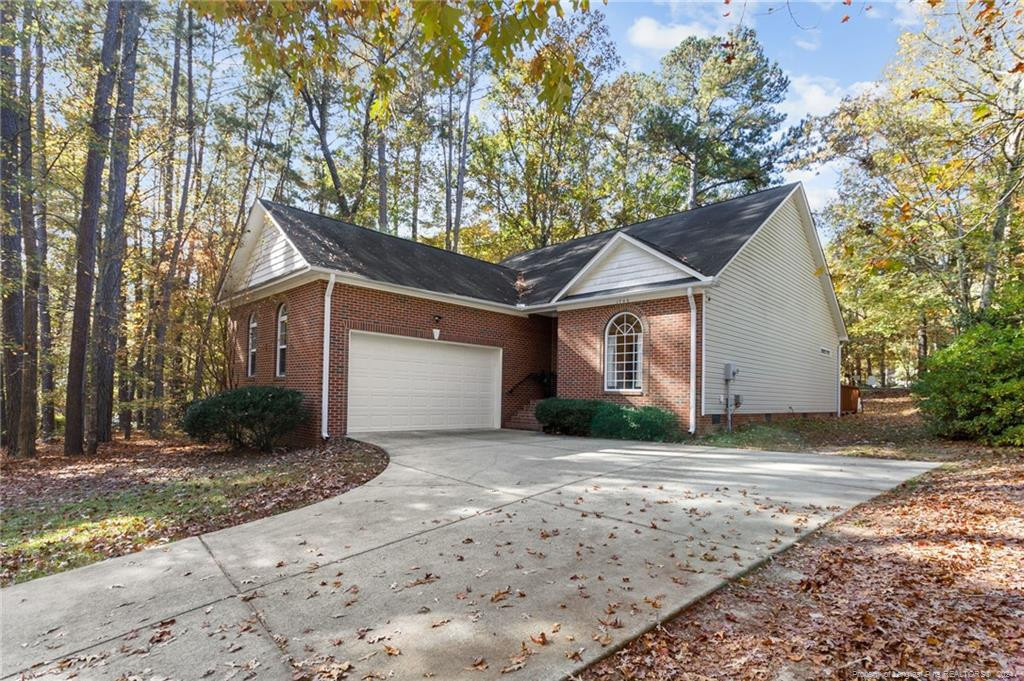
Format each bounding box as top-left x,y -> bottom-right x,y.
702,195 -> 840,414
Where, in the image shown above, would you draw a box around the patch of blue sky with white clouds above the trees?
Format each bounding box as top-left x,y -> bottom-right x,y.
591,0 -> 927,210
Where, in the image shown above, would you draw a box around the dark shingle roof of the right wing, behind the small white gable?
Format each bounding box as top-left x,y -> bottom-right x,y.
502,184 -> 797,304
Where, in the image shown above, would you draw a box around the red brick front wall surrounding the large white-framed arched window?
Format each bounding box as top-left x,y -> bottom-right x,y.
557,295 -> 702,429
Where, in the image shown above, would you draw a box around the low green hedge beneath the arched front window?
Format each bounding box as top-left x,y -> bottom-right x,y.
534,397 -> 681,442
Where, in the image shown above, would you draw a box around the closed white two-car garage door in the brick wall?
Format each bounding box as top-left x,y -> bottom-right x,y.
348,331 -> 502,432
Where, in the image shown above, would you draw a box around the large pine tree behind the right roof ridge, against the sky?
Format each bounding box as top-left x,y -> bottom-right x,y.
644,29 -> 790,208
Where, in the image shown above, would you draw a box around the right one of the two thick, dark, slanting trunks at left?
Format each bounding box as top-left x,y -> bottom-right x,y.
89,2 -> 139,454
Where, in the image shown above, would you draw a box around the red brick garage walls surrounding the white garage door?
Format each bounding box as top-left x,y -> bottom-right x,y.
231,282 -> 552,442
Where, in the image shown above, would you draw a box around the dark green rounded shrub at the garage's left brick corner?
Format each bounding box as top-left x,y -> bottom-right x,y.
182,386 -> 305,451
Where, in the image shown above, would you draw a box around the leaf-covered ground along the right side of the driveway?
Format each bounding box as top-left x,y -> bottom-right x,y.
582,391 -> 1024,681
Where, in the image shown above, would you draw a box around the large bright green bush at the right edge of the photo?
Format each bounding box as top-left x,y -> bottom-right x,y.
913,284 -> 1024,445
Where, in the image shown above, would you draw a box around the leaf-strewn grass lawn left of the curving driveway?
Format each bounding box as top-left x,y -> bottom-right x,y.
0,439 -> 387,586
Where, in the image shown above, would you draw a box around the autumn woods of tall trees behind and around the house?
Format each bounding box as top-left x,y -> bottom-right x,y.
0,0 -> 1024,456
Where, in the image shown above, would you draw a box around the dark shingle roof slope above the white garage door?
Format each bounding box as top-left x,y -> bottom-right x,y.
260,199 -> 519,305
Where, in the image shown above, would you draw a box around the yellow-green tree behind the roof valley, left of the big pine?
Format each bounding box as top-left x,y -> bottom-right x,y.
470,12 -> 621,253
